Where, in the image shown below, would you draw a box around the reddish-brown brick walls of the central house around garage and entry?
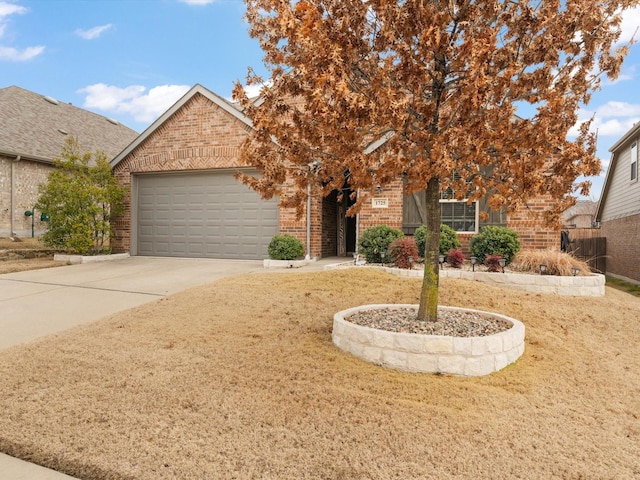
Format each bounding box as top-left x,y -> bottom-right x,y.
113,93 -> 559,258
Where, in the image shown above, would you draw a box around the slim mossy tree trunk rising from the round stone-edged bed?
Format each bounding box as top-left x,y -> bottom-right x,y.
418,178 -> 441,322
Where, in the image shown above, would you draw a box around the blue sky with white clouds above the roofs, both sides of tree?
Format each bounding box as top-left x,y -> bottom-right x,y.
0,0 -> 640,199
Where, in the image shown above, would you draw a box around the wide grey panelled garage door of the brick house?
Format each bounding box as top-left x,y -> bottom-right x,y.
137,171 -> 278,260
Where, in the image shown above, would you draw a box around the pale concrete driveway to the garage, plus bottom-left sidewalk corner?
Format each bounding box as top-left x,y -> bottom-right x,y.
0,257 -> 345,480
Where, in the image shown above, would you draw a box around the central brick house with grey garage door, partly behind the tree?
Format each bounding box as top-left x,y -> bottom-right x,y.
111,85 -> 560,259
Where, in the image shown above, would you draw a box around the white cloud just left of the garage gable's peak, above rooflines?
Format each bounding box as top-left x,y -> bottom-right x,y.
78,83 -> 191,122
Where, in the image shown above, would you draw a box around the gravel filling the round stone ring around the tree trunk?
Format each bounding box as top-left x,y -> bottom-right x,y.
345,307 -> 513,337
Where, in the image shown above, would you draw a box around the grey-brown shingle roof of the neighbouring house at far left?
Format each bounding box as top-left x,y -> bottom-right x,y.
0,86 -> 138,163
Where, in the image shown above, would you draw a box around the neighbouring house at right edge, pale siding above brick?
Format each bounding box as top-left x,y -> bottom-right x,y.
596,122 -> 640,283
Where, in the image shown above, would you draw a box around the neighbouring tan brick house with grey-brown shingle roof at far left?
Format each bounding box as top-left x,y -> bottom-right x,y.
0,86 -> 138,237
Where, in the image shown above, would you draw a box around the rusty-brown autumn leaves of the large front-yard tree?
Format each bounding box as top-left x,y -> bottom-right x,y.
234,0 -> 638,220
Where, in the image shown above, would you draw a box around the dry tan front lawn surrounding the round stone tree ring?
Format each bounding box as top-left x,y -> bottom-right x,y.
0,269 -> 640,480
